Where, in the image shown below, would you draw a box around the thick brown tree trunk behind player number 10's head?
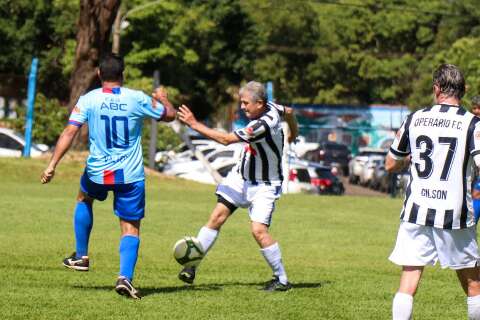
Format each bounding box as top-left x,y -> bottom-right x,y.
68,0 -> 121,144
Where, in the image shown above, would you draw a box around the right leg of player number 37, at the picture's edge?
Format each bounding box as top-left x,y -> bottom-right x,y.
457,267 -> 480,320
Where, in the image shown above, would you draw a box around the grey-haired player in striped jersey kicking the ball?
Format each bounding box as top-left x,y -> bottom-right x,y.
178,81 -> 298,291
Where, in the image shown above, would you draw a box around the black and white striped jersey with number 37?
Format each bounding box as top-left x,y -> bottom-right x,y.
389,104 -> 480,229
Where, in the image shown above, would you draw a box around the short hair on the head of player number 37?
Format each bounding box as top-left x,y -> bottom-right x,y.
433,64 -> 465,99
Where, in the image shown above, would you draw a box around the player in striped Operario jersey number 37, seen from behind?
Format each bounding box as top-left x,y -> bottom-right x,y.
385,64 -> 480,320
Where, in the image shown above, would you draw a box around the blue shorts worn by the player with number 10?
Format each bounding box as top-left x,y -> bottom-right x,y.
80,173 -> 145,221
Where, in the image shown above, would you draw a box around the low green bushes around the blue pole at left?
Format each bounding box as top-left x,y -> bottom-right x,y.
13,93 -> 68,146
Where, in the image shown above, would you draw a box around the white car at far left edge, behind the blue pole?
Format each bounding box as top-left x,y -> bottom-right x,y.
0,128 -> 48,158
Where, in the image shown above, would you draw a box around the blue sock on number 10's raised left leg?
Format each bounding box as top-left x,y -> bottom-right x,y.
73,201 -> 93,258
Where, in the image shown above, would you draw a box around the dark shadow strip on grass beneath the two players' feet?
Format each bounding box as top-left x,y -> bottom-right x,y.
73,280 -> 332,297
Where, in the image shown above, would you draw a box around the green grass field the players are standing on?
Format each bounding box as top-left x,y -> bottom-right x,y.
0,159 -> 472,319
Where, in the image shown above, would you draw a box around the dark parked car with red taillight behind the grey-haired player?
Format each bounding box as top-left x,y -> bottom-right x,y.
303,142 -> 351,175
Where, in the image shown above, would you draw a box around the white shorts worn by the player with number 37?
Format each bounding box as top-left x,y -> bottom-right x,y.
389,221 -> 480,270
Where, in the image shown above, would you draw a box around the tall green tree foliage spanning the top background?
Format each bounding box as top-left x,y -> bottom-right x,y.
4,0 -> 480,115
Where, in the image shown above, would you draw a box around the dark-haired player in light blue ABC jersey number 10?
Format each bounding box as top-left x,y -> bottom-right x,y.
41,55 -> 176,299
